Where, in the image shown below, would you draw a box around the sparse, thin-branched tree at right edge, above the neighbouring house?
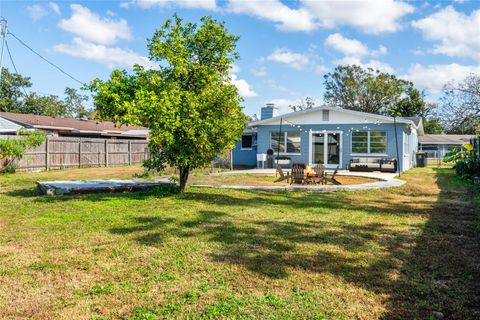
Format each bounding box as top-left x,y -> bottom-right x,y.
440,74 -> 480,134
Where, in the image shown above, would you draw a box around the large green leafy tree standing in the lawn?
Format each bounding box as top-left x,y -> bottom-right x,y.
91,16 -> 246,190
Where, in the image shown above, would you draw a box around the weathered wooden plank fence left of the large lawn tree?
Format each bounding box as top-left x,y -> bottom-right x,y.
0,136 -> 148,170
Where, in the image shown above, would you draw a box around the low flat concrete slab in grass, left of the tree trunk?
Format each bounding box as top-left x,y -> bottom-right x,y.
37,179 -> 170,195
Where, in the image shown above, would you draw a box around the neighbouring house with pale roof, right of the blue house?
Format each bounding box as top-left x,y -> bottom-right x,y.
418,134 -> 475,158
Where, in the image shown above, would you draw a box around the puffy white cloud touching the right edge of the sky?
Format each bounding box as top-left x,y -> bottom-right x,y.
412,6 -> 480,61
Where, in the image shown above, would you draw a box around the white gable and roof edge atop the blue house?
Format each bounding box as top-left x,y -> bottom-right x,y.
249,106 -> 418,129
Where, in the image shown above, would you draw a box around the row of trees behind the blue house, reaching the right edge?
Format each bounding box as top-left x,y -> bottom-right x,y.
324,65 -> 480,134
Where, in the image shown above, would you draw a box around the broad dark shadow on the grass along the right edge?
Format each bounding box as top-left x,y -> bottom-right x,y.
383,169 -> 480,319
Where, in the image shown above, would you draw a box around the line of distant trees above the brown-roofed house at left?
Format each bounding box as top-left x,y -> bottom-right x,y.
0,68 -> 95,118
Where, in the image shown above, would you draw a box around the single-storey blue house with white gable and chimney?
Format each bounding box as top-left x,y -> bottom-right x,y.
232,104 -> 423,171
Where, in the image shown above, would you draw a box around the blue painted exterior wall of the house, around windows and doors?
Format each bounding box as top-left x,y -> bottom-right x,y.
244,123 -> 415,171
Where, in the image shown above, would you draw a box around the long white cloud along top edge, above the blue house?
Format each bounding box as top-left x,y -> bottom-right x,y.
226,0 -> 414,34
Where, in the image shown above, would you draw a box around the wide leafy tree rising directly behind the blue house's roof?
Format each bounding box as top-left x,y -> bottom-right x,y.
324,65 -> 425,117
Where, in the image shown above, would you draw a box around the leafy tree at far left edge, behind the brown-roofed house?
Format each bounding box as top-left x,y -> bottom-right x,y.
0,68 -> 32,112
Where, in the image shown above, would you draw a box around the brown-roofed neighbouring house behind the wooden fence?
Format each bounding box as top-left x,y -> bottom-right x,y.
0,112 -> 148,139
